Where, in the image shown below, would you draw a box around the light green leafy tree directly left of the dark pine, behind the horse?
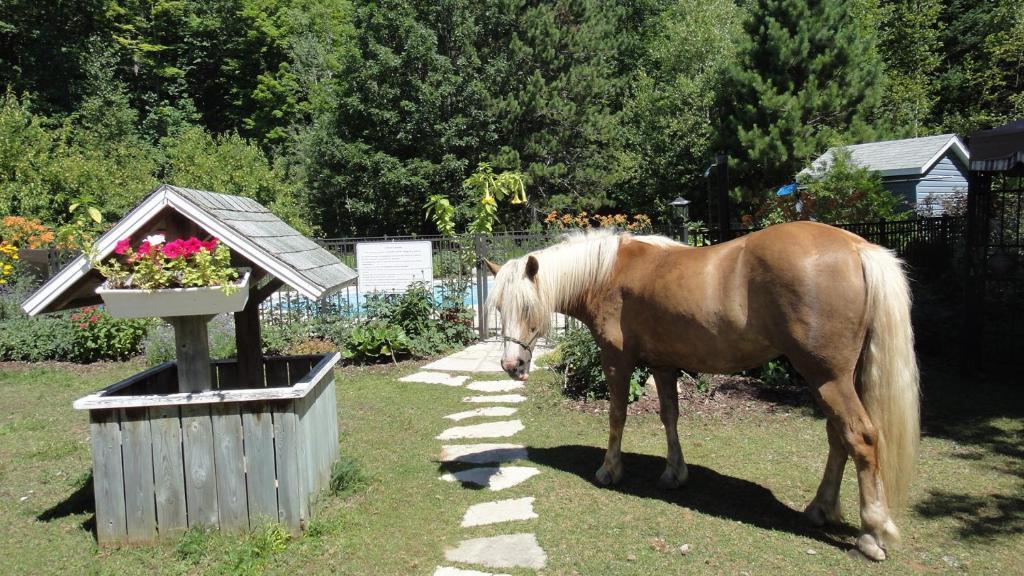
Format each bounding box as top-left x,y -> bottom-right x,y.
614,0 -> 742,219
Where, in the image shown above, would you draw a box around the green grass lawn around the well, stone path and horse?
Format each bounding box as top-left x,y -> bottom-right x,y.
0,356 -> 1024,575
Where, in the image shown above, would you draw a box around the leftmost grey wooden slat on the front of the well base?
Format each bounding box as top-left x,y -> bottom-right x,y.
89,410 -> 128,545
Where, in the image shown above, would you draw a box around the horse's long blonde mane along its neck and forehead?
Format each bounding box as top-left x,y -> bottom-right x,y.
487,229 -> 681,333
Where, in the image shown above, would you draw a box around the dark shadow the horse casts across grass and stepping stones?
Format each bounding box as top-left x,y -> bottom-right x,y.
440,445 -> 857,550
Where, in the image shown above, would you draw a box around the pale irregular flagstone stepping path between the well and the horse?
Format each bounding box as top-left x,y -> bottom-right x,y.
417,342 -> 548,576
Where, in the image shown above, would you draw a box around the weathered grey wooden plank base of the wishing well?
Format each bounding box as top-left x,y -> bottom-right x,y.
75,354 -> 340,544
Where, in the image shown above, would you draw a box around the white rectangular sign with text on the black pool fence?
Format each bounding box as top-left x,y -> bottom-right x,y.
355,240 -> 434,292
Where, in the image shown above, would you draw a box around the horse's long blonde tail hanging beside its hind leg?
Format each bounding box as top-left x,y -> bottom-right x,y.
859,244 -> 921,510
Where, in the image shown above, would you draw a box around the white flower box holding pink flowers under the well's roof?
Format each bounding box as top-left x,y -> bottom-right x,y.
96,269 -> 250,318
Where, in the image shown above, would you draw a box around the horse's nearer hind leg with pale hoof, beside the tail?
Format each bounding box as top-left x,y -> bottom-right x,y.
817,375 -> 899,561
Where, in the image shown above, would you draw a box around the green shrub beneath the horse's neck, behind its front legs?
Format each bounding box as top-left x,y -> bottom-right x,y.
552,327 -> 650,402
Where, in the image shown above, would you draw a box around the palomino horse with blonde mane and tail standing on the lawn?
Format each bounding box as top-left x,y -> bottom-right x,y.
487,222 -> 919,560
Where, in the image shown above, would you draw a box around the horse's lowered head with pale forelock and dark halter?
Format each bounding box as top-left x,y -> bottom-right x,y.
486,255 -> 551,380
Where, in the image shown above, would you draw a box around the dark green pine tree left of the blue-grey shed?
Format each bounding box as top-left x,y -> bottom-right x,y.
723,0 -> 882,196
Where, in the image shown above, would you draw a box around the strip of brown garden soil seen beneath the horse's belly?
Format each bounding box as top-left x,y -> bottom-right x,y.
566,374 -> 813,417
